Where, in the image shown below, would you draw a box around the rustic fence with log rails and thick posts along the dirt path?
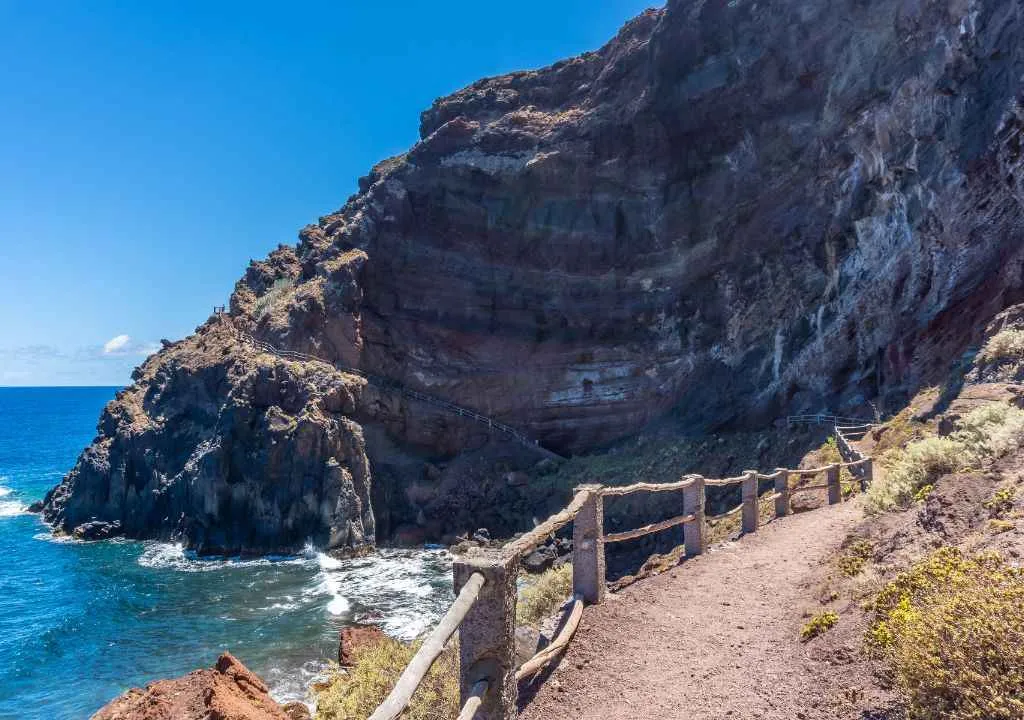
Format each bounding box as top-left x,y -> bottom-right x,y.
370,425 -> 872,720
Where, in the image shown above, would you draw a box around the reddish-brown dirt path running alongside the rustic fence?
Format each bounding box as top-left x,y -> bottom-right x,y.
520,502 -> 860,720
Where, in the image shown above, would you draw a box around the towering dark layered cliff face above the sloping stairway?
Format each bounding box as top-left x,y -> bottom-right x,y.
247,0 -> 1024,451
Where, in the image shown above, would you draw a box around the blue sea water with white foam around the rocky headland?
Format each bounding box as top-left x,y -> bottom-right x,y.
0,387 -> 452,720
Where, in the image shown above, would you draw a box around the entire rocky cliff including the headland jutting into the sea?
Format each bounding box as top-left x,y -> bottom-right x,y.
45,0 -> 1024,549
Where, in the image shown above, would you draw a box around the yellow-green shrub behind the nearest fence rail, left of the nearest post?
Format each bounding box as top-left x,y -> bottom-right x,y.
316,638 -> 460,720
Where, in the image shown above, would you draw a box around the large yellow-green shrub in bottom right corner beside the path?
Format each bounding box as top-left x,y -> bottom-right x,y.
867,547 -> 1024,720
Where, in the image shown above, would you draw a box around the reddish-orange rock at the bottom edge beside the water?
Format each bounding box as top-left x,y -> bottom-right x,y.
92,652 -> 309,720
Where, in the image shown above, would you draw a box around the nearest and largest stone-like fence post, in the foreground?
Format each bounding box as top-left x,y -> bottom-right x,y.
454,548 -> 519,720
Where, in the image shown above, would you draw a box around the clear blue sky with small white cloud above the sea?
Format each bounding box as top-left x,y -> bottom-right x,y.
0,0 -> 657,385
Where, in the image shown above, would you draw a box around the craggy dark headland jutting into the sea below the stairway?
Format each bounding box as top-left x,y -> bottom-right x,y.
43,320 -> 374,554
